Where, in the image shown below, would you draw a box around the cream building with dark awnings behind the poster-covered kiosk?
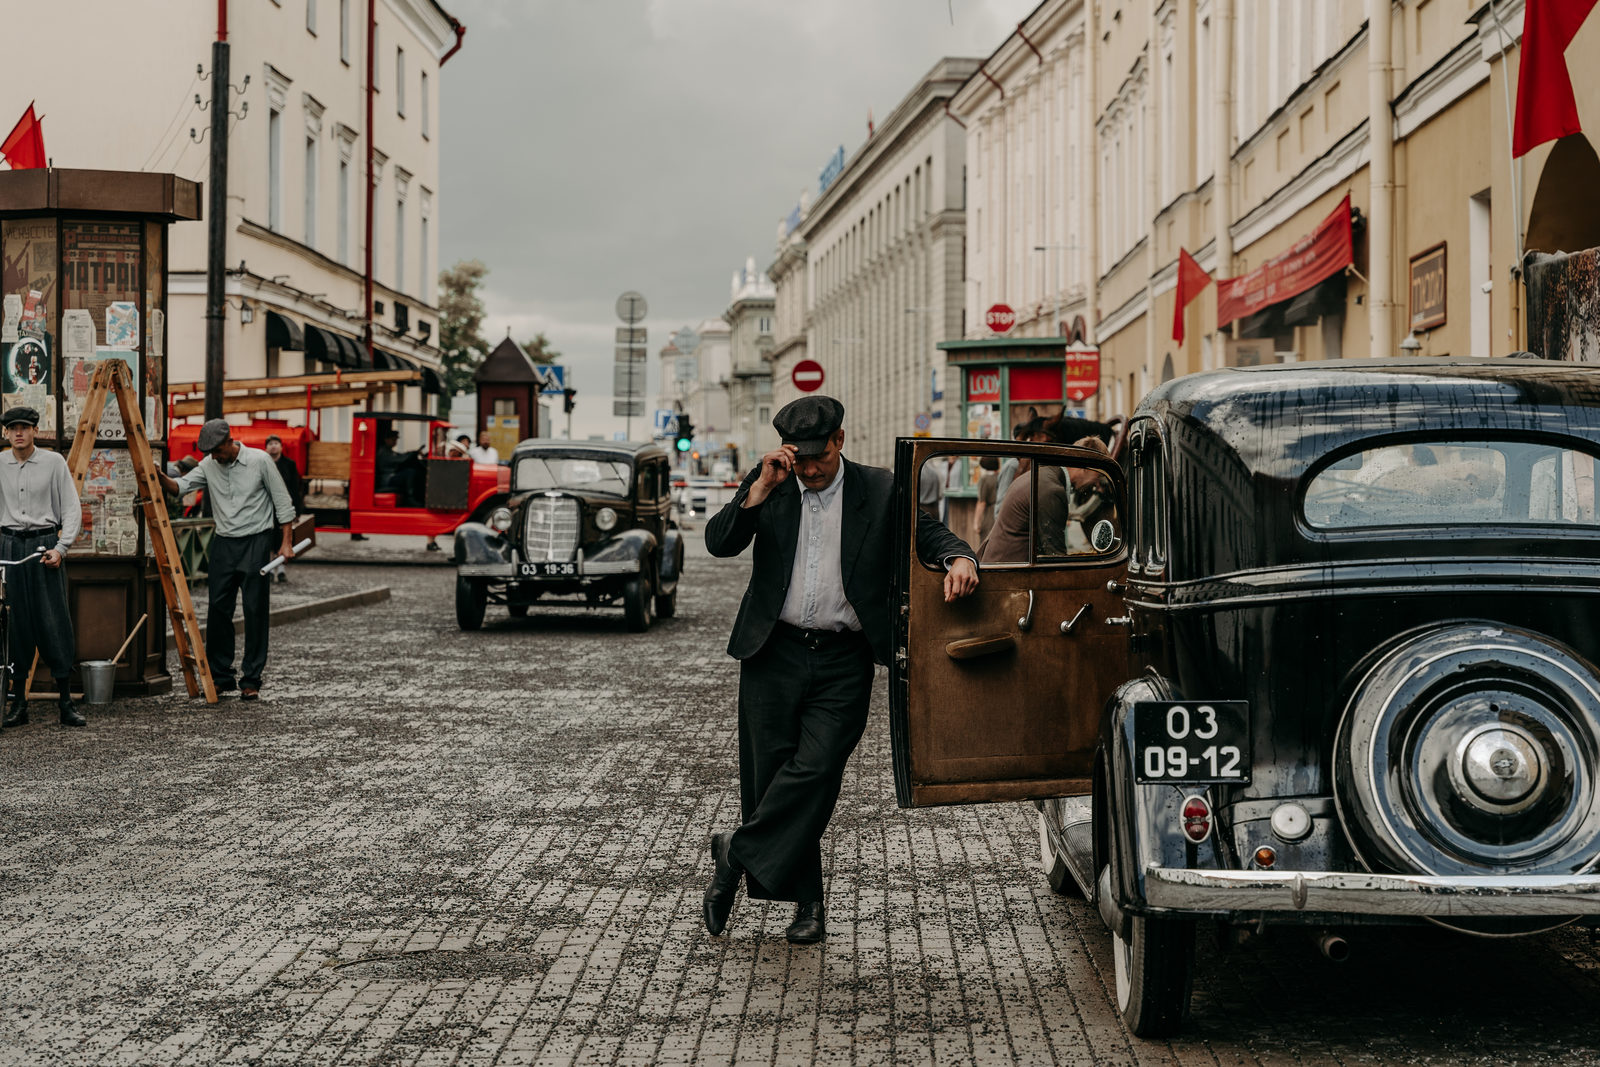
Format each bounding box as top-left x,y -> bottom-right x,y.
0,0 -> 464,435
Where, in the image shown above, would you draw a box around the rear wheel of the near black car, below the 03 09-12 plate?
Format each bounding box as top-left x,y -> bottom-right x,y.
1099,865 -> 1195,1037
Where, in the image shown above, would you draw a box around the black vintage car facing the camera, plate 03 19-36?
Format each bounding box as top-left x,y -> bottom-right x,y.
456,440 -> 683,632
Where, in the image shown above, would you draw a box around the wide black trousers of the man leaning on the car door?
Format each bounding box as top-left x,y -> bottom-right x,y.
731,624 -> 872,901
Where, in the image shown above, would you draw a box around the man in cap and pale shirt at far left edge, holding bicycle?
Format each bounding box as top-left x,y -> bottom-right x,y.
0,408 -> 85,726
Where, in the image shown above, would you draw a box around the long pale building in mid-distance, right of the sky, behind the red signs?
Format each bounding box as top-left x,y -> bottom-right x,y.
768,58 -> 978,466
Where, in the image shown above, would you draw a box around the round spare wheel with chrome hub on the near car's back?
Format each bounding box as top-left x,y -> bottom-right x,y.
1333,621 -> 1600,875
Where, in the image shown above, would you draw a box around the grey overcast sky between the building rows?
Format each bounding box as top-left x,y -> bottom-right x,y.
440,0 -> 1037,437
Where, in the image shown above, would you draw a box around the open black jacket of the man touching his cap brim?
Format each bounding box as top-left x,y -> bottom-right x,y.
706,459 -> 976,664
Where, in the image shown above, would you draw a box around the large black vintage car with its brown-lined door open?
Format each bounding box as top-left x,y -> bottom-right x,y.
891,360 -> 1600,1037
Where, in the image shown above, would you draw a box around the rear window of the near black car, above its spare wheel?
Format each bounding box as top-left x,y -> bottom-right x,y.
1304,442 -> 1600,530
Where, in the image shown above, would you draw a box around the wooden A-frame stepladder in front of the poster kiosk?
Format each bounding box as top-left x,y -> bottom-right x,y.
67,358 -> 216,704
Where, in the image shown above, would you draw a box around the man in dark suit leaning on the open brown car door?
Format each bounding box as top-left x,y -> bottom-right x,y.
704,397 -> 978,944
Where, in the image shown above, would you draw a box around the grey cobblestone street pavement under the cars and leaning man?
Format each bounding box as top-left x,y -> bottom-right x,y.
0,534 -> 1600,1065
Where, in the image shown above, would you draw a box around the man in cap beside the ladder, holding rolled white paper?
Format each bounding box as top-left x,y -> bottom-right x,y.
160,419 -> 294,701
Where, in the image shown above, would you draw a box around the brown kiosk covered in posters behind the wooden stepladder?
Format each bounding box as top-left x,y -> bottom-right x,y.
0,168 -> 200,696
